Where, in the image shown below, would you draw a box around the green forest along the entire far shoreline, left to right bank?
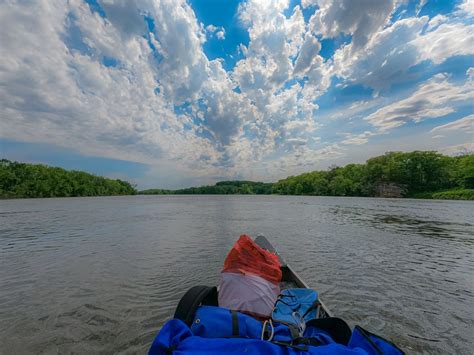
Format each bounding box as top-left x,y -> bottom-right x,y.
0,151 -> 474,200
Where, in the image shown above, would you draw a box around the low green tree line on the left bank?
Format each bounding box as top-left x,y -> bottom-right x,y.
0,159 -> 137,198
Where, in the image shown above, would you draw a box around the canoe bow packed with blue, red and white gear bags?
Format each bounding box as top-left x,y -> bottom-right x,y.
149,235 -> 404,355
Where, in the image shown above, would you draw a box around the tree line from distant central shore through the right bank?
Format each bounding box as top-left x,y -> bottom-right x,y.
140,151 -> 474,199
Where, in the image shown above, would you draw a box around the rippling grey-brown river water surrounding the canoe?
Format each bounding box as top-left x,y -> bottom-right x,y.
0,196 -> 474,354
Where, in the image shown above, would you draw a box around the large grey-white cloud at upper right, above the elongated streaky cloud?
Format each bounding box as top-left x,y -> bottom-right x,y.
331,16 -> 474,91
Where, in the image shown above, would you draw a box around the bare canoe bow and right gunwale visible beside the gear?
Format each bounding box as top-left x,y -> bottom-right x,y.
255,235 -> 332,318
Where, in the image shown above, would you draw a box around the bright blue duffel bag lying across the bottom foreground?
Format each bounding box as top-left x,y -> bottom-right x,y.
149,306 -> 403,355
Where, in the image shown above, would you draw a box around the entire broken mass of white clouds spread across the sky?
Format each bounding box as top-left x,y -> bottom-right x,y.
0,0 -> 474,184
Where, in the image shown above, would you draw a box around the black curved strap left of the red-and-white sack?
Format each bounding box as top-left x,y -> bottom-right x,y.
174,286 -> 217,327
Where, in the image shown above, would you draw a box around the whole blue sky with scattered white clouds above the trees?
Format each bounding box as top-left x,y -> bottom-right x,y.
0,0 -> 474,188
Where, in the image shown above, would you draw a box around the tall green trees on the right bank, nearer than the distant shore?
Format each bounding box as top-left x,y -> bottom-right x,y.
273,151 -> 474,197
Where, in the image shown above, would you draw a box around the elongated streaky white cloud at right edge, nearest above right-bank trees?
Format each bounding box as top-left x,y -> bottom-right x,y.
365,74 -> 474,132
